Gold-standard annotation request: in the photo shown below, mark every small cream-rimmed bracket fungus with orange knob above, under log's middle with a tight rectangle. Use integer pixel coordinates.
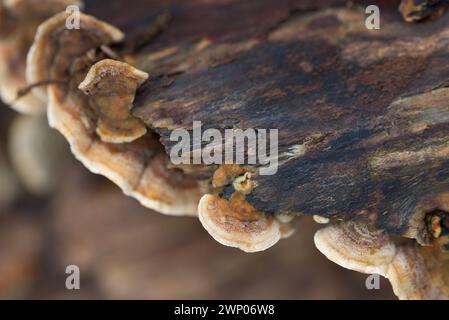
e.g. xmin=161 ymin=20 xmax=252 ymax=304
xmin=198 ymin=164 xmax=295 ymax=252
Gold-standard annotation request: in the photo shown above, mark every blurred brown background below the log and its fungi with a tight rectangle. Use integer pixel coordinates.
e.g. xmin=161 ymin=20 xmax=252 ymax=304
xmin=0 ymin=106 xmax=394 ymax=299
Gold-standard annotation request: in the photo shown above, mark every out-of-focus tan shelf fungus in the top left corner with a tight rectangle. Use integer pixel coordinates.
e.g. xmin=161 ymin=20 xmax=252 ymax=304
xmin=0 ymin=0 xmax=82 ymax=114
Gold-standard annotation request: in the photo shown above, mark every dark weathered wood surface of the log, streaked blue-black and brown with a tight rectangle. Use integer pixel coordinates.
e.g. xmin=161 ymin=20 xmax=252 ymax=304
xmin=96 ymin=1 xmax=449 ymax=239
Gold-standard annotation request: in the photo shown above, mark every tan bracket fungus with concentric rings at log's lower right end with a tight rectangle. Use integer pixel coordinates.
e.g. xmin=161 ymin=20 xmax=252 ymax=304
xmin=315 ymin=222 xmax=449 ymax=299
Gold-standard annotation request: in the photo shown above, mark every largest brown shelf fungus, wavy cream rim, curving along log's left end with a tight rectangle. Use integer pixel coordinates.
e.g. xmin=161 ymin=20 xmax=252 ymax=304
xmin=27 ymin=13 xmax=200 ymax=215
